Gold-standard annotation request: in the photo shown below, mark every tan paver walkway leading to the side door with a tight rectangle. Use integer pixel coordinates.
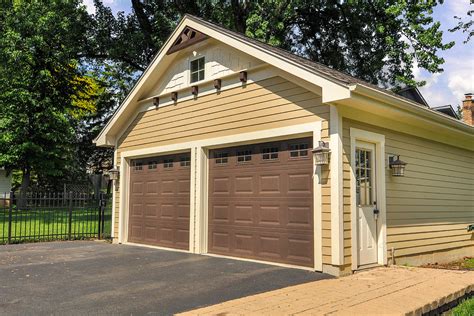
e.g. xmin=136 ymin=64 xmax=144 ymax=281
xmin=181 ymin=267 xmax=474 ymax=315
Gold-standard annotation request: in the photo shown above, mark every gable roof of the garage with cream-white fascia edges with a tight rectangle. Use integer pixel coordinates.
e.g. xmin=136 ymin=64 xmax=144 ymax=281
xmin=94 ymin=15 xmax=474 ymax=146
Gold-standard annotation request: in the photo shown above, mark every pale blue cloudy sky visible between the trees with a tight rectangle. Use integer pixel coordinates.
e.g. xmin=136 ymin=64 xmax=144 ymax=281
xmin=83 ymin=0 xmax=474 ymax=108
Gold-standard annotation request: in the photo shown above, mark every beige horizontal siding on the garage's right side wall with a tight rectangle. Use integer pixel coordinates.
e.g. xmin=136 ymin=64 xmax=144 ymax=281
xmin=343 ymin=119 xmax=474 ymax=263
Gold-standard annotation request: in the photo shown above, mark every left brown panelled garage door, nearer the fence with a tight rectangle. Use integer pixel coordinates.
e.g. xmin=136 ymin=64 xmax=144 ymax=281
xmin=128 ymin=154 xmax=191 ymax=249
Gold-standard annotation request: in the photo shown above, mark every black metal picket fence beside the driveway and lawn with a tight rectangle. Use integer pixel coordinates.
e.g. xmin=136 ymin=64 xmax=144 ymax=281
xmin=0 ymin=192 xmax=112 ymax=244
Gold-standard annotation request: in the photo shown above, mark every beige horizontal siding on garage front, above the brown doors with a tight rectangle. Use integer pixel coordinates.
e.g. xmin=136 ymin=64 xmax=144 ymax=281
xmin=114 ymin=77 xmax=330 ymax=237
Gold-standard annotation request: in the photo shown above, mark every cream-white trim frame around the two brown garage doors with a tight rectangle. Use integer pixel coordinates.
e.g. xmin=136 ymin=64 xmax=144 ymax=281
xmin=118 ymin=121 xmax=322 ymax=271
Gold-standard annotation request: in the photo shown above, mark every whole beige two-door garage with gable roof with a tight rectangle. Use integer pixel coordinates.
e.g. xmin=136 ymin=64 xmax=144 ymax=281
xmin=95 ymin=15 xmax=474 ymax=275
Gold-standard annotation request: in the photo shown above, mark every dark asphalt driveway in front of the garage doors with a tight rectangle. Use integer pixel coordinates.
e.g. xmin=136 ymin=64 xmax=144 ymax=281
xmin=0 ymin=241 xmax=330 ymax=315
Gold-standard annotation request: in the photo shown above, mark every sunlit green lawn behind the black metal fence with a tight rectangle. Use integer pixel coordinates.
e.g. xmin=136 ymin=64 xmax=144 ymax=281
xmin=0 ymin=206 xmax=112 ymax=244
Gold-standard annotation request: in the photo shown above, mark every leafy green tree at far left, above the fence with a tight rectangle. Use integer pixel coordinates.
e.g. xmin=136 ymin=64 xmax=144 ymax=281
xmin=0 ymin=0 xmax=94 ymax=190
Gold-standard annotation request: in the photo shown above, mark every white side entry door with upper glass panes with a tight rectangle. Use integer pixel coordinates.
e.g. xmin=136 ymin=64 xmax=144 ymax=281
xmin=355 ymin=141 xmax=378 ymax=266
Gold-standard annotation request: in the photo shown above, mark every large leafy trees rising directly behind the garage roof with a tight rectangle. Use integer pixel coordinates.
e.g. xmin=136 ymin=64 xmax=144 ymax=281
xmin=90 ymin=0 xmax=454 ymax=88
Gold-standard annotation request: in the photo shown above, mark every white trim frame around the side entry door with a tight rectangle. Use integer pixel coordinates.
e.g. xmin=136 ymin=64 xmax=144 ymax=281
xmin=350 ymin=127 xmax=387 ymax=270
